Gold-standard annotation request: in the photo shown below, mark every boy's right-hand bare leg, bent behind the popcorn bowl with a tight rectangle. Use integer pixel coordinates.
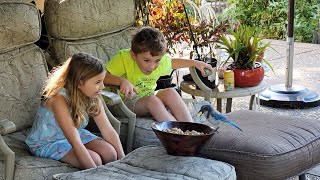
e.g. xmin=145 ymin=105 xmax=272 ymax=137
xmin=156 ymin=88 xmax=193 ymax=122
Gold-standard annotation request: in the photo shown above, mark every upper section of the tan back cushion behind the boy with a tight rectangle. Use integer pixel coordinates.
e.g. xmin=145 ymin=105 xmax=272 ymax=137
xmin=44 ymin=0 xmax=135 ymax=40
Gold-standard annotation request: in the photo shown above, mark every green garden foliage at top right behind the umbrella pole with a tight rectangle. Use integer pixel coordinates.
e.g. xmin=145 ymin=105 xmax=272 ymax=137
xmin=221 ymin=0 xmax=320 ymax=42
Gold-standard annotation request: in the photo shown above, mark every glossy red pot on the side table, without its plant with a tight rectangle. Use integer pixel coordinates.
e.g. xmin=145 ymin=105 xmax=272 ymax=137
xmin=233 ymin=63 xmax=264 ymax=87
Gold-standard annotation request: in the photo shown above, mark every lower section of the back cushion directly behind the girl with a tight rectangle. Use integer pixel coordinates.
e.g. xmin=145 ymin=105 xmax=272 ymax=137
xmin=0 ymin=44 xmax=47 ymax=130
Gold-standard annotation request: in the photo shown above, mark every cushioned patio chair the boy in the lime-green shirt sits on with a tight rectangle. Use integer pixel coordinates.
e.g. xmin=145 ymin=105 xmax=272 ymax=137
xmin=44 ymin=0 xmax=210 ymax=153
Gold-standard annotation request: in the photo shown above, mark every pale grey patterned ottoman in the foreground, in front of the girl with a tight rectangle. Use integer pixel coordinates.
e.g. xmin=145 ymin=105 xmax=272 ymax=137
xmin=53 ymin=146 xmax=236 ymax=180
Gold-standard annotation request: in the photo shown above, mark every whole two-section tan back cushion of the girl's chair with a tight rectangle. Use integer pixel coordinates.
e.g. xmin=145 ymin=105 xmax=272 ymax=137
xmin=0 ymin=3 xmax=47 ymax=130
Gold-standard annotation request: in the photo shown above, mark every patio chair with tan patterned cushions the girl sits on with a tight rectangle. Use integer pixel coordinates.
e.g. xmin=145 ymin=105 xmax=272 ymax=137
xmin=0 ymin=0 xmax=131 ymax=180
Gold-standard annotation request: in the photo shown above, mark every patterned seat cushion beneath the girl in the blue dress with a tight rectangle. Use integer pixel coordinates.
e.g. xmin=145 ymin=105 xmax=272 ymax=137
xmin=0 ymin=130 xmax=78 ymax=180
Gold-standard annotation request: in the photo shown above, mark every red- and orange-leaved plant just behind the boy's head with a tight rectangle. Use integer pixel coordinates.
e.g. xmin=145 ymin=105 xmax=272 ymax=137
xmin=149 ymin=0 xmax=229 ymax=88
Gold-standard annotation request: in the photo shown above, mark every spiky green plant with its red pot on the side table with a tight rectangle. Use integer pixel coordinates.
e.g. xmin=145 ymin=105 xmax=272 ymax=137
xmin=218 ymin=25 xmax=273 ymax=87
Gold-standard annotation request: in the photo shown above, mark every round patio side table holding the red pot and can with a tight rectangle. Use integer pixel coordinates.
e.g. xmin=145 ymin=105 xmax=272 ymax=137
xmin=180 ymin=80 xmax=268 ymax=113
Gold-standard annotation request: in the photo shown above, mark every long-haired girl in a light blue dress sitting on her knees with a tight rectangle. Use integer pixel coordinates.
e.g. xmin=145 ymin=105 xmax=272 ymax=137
xmin=26 ymin=53 xmax=124 ymax=169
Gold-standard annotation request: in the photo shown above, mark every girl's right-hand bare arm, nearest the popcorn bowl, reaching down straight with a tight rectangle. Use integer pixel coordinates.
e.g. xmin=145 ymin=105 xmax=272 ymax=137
xmin=93 ymin=102 xmax=125 ymax=159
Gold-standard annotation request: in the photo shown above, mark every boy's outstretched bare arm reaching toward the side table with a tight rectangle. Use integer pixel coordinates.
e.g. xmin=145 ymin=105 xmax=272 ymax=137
xmin=172 ymin=58 xmax=213 ymax=75
